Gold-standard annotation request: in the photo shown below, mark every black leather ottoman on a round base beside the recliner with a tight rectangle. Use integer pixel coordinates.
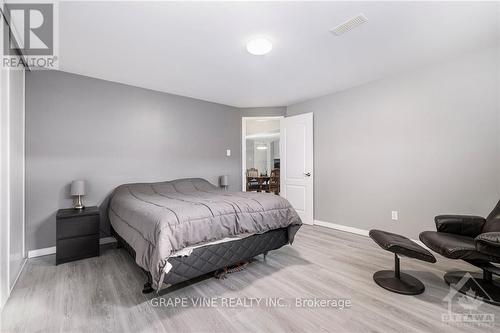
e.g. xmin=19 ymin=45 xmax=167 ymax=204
xmin=370 ymin=230 xmax=436 ymax=295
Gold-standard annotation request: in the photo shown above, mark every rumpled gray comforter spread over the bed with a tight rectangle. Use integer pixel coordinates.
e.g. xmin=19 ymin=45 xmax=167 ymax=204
xmin=109 ymin=178 xmax=302 ymax=289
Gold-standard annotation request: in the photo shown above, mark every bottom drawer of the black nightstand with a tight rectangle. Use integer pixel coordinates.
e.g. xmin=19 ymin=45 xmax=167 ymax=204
xmin=56 ymin=234 xmax=99 ymax=264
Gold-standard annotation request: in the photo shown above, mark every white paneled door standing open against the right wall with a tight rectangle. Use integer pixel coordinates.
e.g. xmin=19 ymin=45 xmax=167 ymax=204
xmin=281 ymin=113 xmax=314 ymax=224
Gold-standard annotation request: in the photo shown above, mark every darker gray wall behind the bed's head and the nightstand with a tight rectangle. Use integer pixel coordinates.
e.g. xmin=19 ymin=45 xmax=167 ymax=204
xmin=26 ymin=71 xmax=241 ymax=250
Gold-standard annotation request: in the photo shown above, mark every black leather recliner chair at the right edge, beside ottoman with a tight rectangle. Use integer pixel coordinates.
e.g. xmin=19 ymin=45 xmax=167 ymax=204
xmin=420 ymin=201 xmax=500 ymax=305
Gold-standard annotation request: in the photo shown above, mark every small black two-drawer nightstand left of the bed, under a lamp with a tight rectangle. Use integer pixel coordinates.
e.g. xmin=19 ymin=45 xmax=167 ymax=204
xmin=56 ymin=207 xmax=99 ymax=265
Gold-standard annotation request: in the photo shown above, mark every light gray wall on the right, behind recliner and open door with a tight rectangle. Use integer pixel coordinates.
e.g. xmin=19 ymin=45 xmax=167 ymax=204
xmin=287 ymin=49 xmax=500 ymax=238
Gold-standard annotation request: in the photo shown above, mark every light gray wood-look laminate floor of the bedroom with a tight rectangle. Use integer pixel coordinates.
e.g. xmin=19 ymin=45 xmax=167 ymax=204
xmin=0 ymin=226 xmax=500 ymax=333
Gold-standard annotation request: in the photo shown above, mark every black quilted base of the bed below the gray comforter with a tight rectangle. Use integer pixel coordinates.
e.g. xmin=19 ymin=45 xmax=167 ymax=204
xmin=111 ymin=228 xmax=290 ymax=294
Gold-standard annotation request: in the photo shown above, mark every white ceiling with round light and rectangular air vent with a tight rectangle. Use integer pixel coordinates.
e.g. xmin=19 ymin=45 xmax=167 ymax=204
xmin=59 ymin=2 xmax=500 ymax=107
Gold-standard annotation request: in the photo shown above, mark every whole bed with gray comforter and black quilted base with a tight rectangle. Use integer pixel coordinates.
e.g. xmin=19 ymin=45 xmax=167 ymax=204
xmin=108 ymin=178 xmax=302 ymax=292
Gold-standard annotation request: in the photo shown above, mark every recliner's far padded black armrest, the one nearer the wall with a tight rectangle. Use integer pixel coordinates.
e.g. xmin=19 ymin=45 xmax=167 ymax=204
xmin=434 ymin=215 xmax=486 ymax=237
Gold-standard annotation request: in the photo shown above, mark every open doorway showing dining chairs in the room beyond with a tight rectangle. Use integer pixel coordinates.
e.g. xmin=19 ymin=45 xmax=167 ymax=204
xmin=241 ymin=117 xmax=283 ymax=195
